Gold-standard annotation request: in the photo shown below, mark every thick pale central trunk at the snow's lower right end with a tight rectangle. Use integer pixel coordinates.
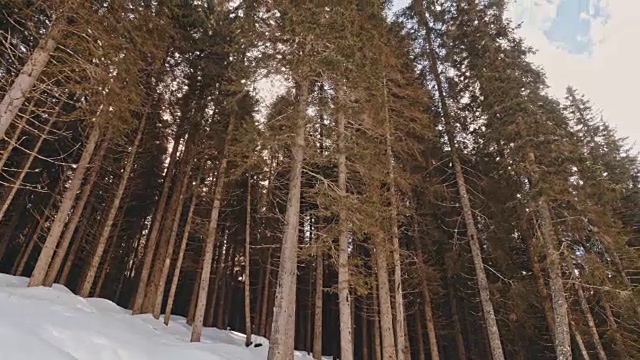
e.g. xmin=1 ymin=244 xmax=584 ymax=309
xmin=267 ymin=80 xmax=309 ymax=360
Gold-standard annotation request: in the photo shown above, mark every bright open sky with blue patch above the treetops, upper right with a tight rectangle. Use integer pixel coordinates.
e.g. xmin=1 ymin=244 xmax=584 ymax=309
xmin=394 ymin=0 xmax=640 ymax=151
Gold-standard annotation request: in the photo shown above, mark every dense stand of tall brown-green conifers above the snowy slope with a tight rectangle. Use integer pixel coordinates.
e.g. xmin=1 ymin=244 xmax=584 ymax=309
xmin=0 ymin=0 xmax=640 ymax=360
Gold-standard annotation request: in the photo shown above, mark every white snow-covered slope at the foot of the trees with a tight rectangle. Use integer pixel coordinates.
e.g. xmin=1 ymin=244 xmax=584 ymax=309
xmin=0 ymin=274 xmax=310 ymax=360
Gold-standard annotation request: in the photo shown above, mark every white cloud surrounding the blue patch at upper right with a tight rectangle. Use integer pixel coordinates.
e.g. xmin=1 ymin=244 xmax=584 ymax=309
xmin=509 ymin=0 xmax=640 ymax=148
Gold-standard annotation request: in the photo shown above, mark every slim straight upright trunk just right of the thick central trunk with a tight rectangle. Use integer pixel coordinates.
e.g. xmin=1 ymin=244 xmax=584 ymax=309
xmin=337 ymin=105 xmax=356 ymax=360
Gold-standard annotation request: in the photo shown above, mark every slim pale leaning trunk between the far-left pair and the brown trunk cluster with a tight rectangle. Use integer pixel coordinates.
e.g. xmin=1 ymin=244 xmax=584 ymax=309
xmin=80 ymin=112 xmax=147 ymax=297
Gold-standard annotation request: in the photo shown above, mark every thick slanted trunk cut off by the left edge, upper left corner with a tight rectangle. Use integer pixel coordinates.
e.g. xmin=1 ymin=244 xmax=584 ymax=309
xmin=0 ymin=20 xmax=60 ymax=138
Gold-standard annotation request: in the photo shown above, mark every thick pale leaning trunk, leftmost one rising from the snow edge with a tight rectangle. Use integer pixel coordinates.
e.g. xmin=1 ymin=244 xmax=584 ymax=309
xmin=29 ymin=123 xmax=100 ymax=286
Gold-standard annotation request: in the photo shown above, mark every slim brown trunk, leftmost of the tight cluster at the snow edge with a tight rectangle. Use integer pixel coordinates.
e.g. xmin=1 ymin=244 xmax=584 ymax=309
xmin=132 ymin=131 xmax=182 ymax=315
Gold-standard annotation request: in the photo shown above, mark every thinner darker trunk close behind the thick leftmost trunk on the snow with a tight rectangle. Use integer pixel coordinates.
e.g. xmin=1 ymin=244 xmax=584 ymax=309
xmin=44 ymin=134 xmax=109 ymax=286
